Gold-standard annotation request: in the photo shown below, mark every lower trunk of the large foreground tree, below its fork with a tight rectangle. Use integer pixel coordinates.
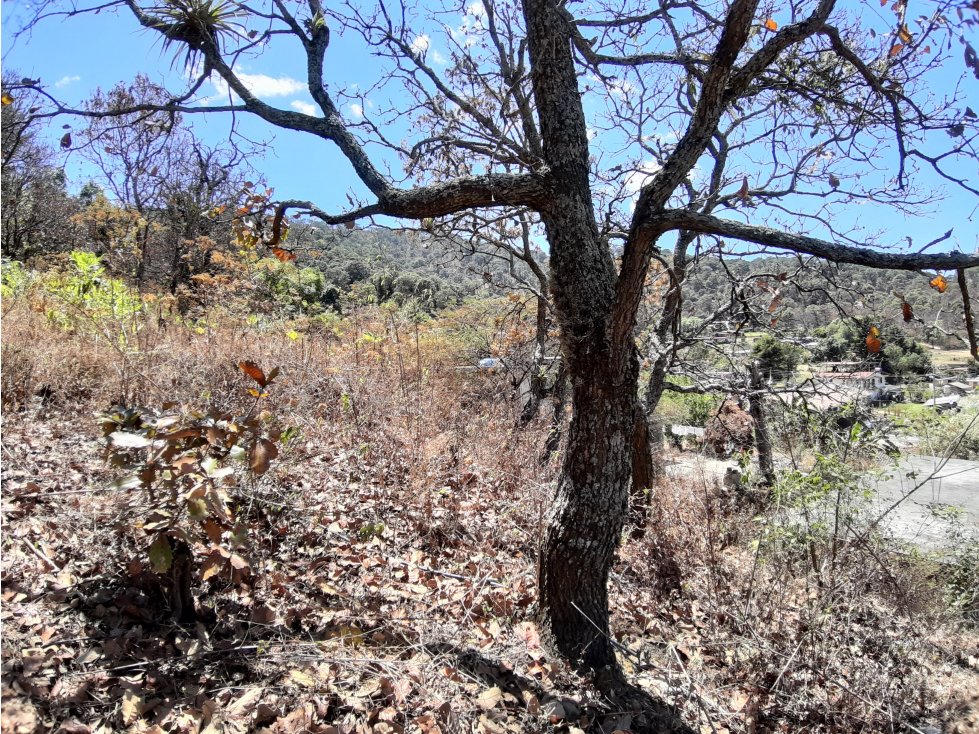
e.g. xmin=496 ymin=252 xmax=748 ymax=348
xmin=537 ymin=356 xmax=637 ymax=670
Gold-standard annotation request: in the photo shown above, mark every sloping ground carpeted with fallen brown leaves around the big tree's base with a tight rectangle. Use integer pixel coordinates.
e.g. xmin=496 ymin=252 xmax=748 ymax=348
xmin=2 ymin=402 xmax=979 ymax=734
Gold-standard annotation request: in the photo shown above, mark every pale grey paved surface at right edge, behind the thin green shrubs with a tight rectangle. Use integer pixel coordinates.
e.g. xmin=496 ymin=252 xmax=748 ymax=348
xmin=867 ymin=456 xmax=979 ymax=548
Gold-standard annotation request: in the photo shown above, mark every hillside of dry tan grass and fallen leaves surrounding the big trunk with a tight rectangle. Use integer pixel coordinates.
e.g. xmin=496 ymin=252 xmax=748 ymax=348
xmin=3 ymin=304 xmax=979 ymax=734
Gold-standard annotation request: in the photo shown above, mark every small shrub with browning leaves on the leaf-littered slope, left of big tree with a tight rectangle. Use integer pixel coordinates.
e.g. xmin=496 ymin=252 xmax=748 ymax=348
xmin=99 ymin=361 xmax=296 ymax=621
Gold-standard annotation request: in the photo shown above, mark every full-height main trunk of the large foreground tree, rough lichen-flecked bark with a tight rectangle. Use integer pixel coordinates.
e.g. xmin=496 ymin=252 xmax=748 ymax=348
xmin=524 ymin=0 xmax=639 ymax=669
